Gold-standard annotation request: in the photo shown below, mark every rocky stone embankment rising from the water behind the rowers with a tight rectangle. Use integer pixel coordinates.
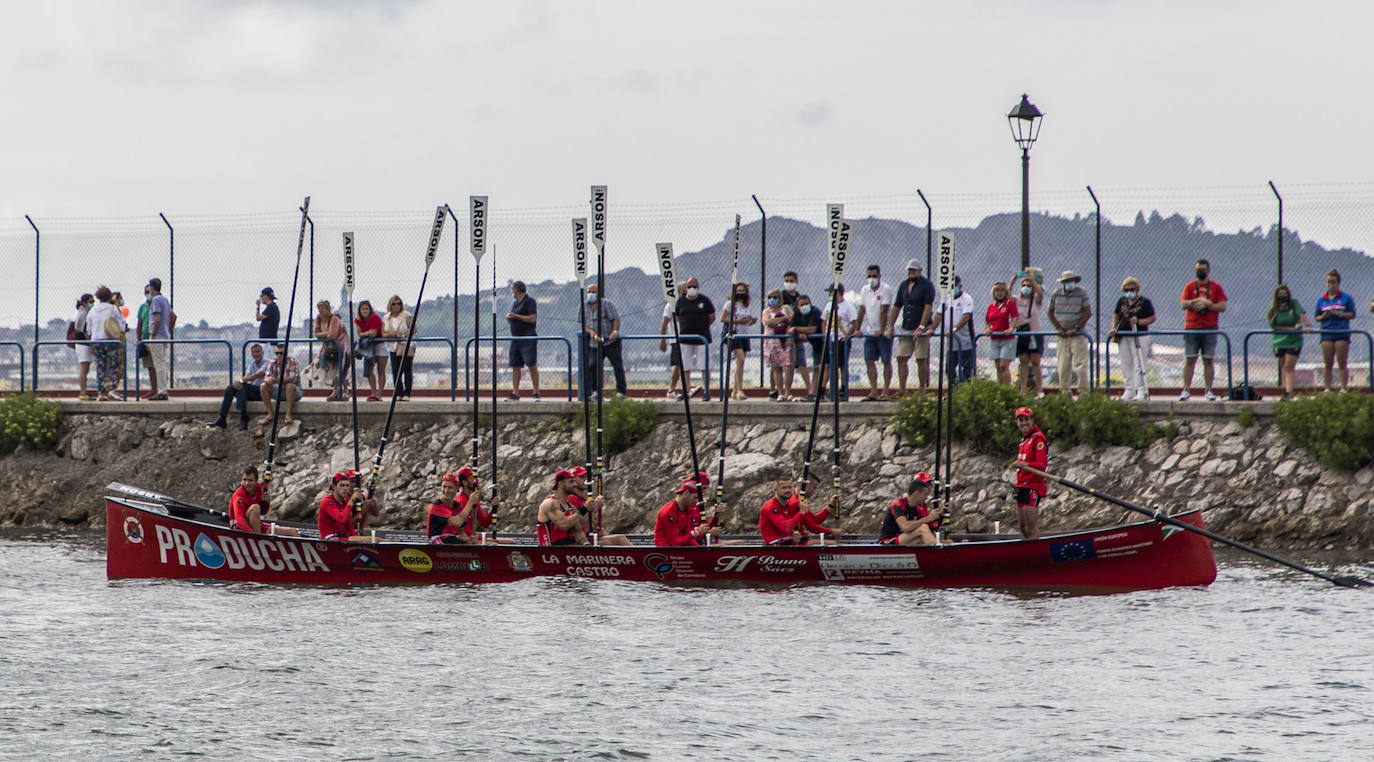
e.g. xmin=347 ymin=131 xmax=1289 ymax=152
xmin=0 ymin=404 xmax=1374 ymax=549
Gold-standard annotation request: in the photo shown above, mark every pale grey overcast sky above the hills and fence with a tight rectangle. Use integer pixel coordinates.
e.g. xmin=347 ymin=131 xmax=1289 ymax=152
xmin=0 ymin=0 xmax=1374 ymax=324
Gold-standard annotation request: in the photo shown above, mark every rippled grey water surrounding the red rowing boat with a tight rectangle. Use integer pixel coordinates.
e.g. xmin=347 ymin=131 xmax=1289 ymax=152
xmin=0 ymin=533 xmax=1374 ymax=761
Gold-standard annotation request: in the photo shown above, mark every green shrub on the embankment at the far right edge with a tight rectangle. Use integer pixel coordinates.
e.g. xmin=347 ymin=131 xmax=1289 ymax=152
xmin=1274 ymin=391 xmax=1374 ymax=471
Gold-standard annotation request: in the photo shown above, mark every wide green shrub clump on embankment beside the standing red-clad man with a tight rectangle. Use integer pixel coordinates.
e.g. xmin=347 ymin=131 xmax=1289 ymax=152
xmin=892 ymin=379 xmax=1169 ymax=454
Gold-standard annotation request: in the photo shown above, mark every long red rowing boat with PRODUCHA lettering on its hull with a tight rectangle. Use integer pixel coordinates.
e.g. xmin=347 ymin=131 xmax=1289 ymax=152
xmin=106 ymin=485 xmax=1216 ymax=592
